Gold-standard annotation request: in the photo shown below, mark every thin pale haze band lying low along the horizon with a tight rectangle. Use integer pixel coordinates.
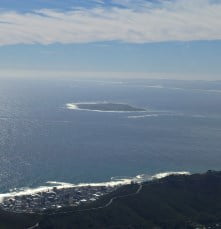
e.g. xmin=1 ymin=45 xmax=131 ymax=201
xmin=0 ymin=69 xmax=220 ymax=81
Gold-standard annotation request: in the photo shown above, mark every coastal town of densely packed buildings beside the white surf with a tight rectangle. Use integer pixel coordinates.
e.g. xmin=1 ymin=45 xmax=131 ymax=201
xmin=0 ymin=185 xmax=117 ymax=213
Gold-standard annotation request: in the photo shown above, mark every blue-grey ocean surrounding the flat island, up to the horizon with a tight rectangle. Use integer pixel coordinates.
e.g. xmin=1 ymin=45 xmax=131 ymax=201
xmin=0 ymin=78 xmax=221 ymax=193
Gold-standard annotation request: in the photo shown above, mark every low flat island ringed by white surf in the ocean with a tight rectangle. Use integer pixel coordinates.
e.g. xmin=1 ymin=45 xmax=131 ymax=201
xmin=67 ymin=102 xmax=146 ymax=112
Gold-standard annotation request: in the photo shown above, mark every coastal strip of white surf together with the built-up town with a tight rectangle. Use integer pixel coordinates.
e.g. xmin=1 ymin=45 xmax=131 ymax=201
xmin=0 ymin=171 xmax=190 ymax=213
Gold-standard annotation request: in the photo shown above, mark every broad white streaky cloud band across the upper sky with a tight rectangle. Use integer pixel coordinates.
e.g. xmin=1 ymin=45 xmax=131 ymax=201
xmin=0 ymin=0 xmax=221 ymax=45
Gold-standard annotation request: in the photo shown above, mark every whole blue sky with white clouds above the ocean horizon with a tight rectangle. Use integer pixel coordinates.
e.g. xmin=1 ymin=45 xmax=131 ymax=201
xmin=0 ymin=0 xmax=221 ymax=80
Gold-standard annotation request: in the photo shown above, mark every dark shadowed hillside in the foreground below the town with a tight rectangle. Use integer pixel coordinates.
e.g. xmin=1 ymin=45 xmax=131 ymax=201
xmin=0 ymin=171 xmax=221 ymax=229
